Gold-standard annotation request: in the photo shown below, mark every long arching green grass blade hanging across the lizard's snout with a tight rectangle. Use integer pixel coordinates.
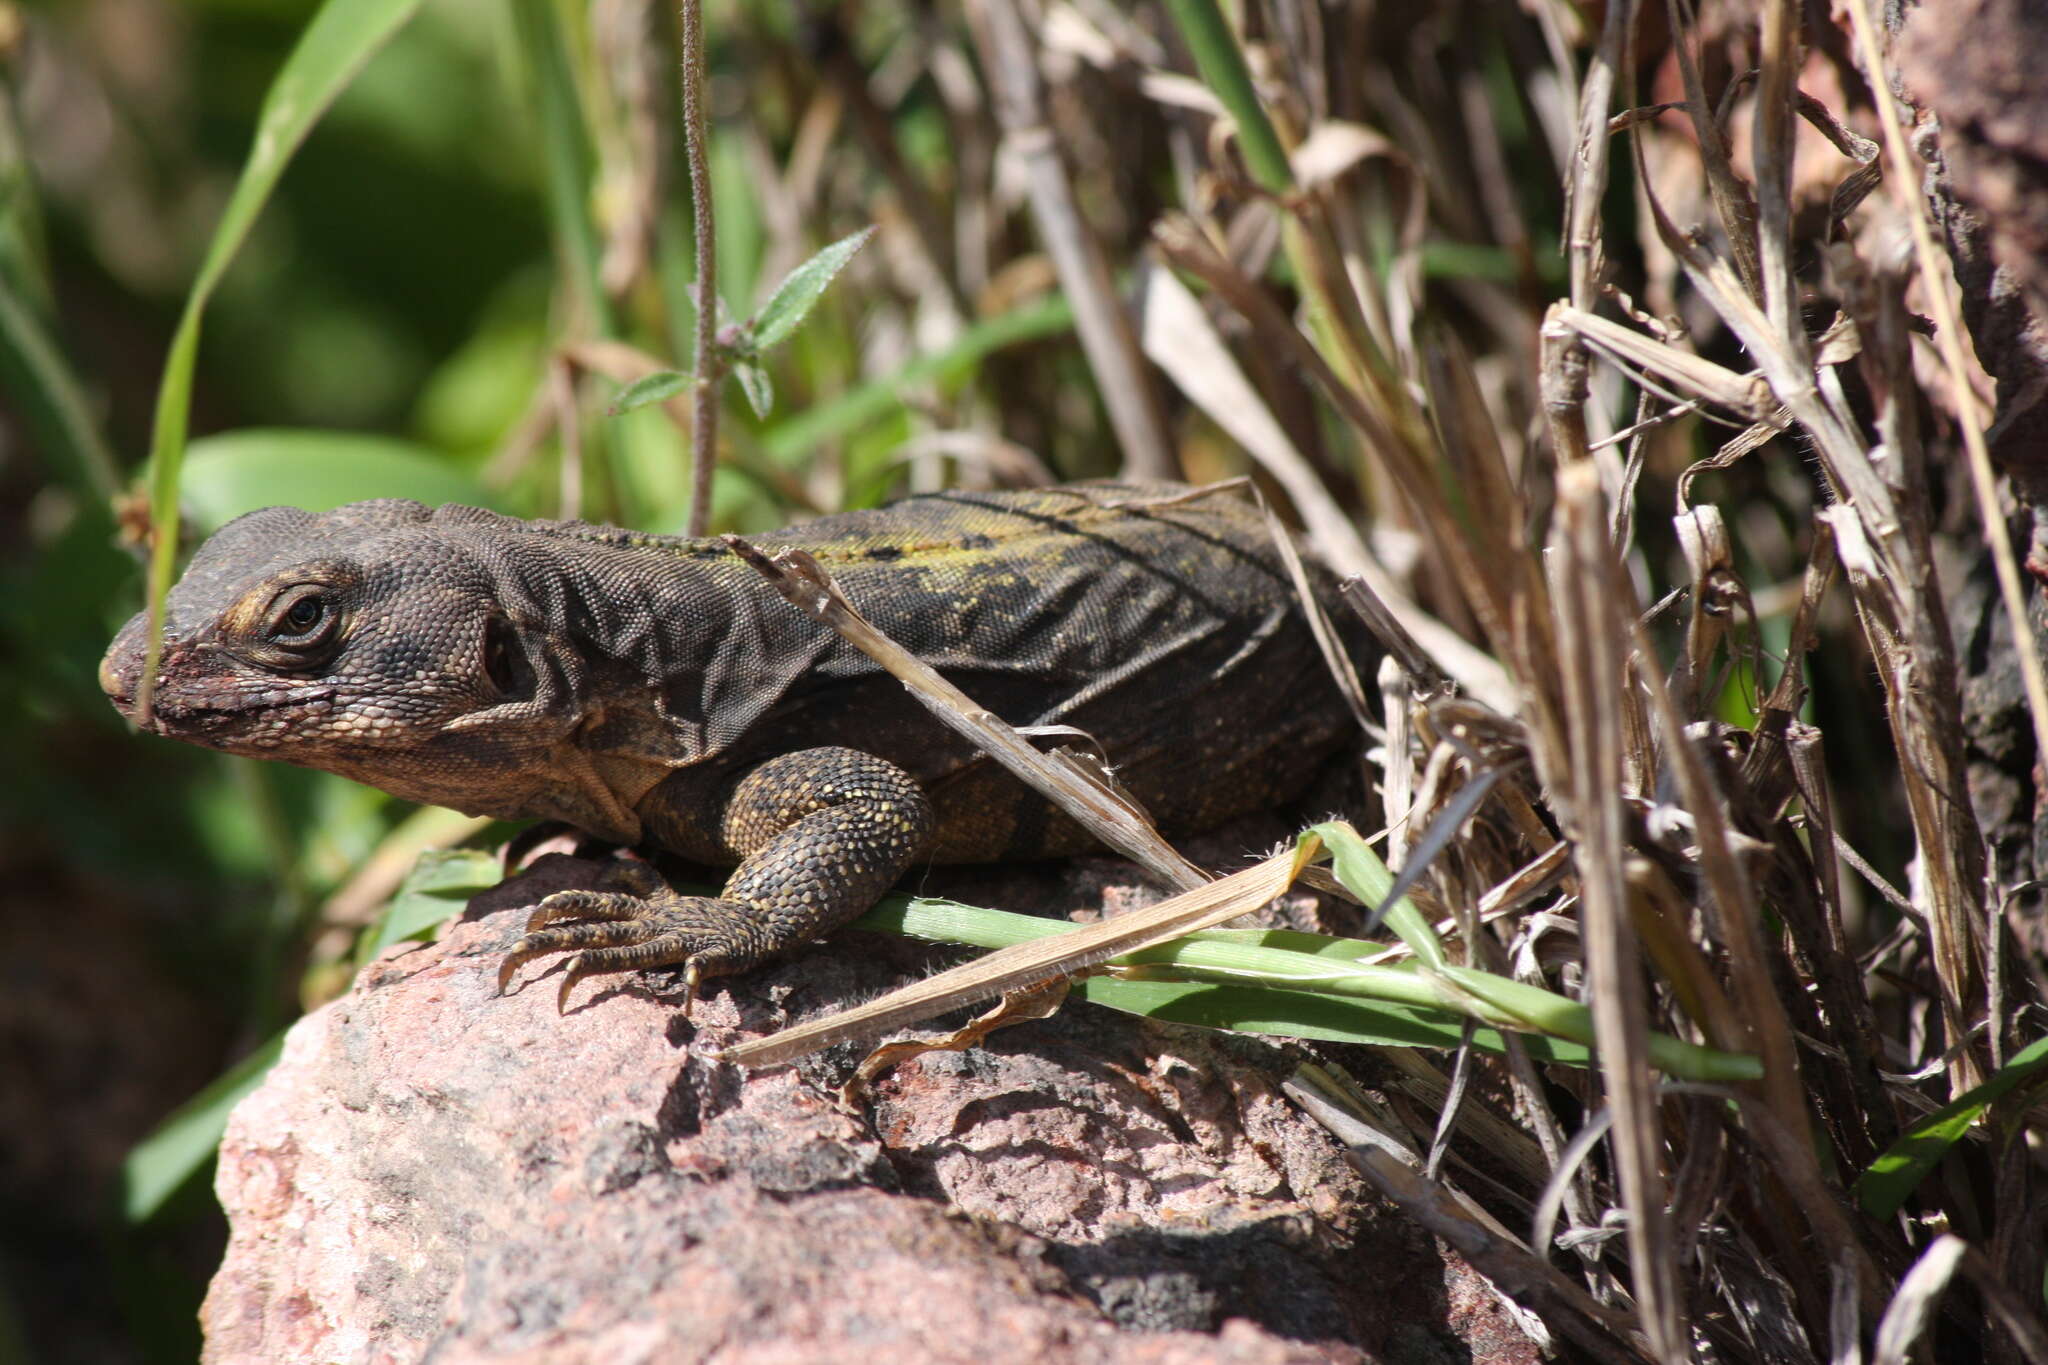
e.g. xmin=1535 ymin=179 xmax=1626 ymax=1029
xmin=145 ymin=0 xmax=432 ymax=703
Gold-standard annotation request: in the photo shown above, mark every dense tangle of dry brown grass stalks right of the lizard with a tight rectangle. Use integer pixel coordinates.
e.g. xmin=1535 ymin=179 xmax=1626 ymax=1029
xmin=638 ymin=0 xmax=2048 ymax=1361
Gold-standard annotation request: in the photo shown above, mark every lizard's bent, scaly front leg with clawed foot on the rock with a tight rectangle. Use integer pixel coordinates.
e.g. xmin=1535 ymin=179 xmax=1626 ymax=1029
xmin=498 ymin=749 xmax=936 ymax=1009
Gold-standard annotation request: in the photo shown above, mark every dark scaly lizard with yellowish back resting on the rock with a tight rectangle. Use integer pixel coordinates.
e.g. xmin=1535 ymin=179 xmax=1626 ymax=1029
xmin=100 ymin=481 xmax=1370 ymax=1001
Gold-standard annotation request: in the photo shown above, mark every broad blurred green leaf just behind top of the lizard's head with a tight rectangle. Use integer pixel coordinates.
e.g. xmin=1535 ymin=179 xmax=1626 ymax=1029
xmin=182 ymin=428 xmax=494 ymax=532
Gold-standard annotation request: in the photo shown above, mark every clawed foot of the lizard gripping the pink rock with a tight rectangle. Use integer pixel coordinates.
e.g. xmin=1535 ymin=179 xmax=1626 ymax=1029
xmin=498 ymin=888 xmax=760 ymax=1013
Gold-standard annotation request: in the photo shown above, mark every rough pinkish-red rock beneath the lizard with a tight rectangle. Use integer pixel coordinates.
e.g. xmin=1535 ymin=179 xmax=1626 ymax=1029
xmin=203 ymin=860 xmax=1538 ymax=1365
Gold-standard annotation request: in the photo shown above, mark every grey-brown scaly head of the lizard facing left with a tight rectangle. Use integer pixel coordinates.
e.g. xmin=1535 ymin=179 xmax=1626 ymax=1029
xmin=100 ymin=499 xmax=547 ymax=802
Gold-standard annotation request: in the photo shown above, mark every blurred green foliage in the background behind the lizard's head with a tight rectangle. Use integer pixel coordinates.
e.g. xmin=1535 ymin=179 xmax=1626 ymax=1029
xmin=0 ymin=0 xmax=1138 ymax=1359
